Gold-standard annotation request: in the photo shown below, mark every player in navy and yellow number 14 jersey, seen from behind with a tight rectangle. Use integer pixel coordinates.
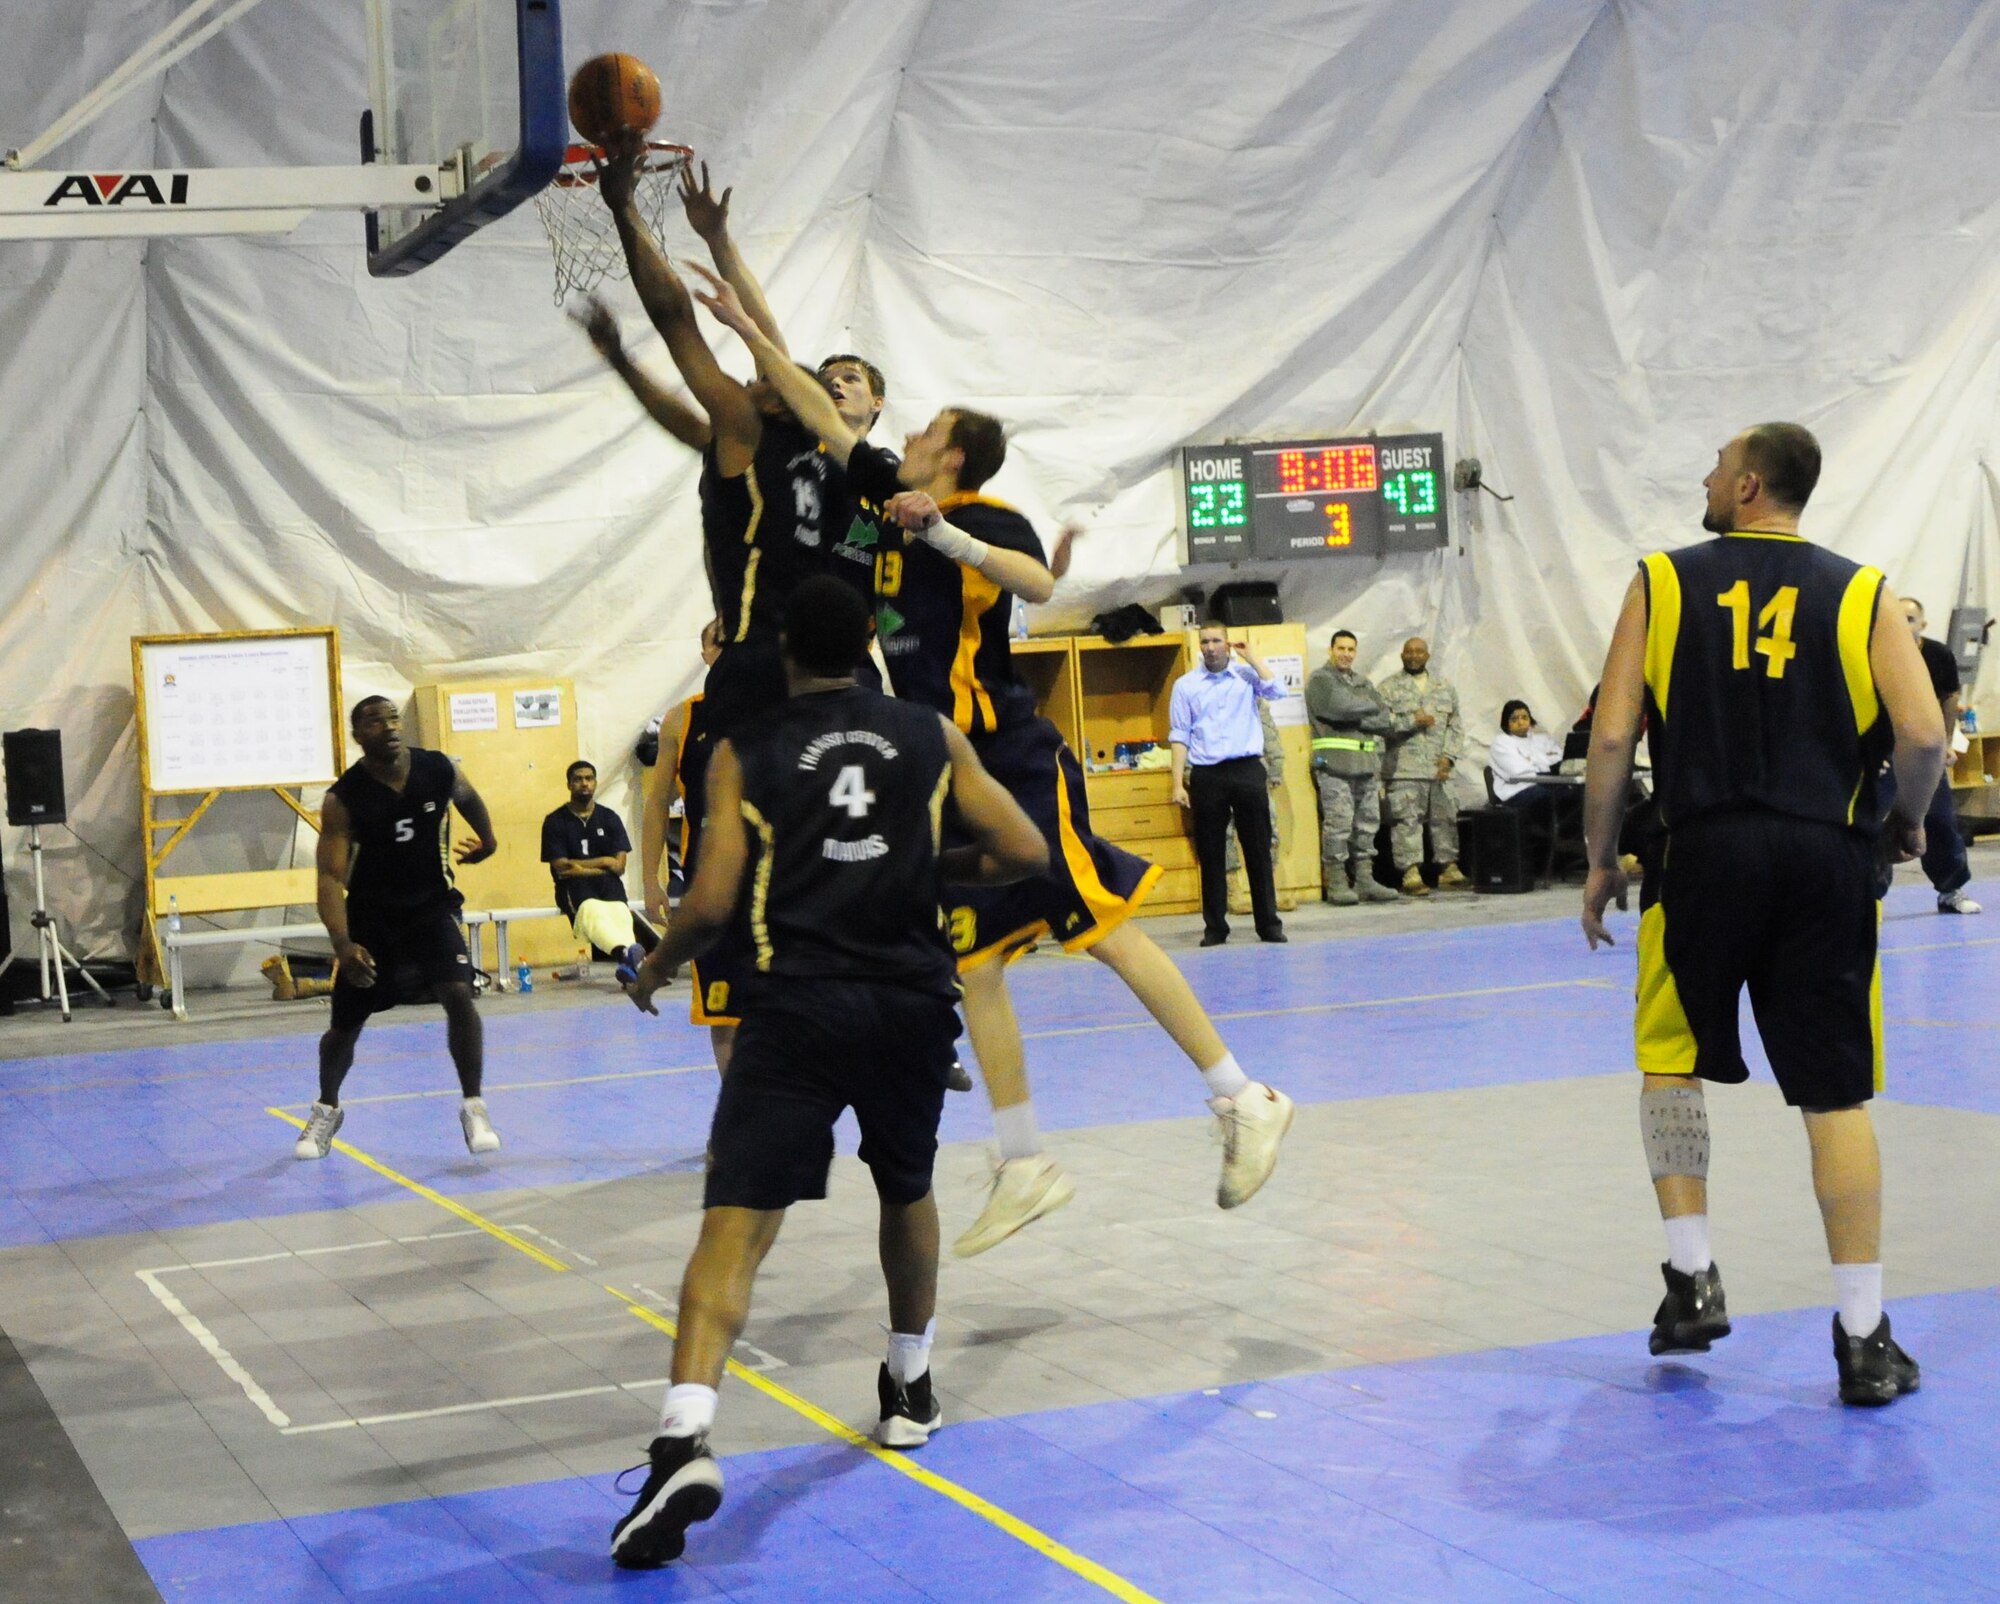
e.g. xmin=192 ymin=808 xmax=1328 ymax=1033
xmin=1584 ymin=424 xmax=1944 ymax=1404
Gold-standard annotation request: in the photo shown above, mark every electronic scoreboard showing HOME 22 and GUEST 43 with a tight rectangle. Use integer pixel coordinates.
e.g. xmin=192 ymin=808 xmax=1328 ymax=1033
xmin=1180 ymin=434 xmax=1450 ymax=562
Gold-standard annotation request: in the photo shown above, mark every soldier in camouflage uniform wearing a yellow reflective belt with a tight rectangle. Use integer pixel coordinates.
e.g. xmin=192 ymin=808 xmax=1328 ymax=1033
xmin=1306 ymin=630 xmax=1396 ymax=908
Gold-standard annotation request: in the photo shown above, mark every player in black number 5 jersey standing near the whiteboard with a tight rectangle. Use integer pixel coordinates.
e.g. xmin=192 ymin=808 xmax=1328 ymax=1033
xmin=294 ymin=696 xmax=500 ymax=1158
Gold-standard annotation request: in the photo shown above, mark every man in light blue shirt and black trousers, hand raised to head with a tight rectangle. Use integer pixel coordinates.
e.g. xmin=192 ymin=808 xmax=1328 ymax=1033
xmin=1168 ymin=624 xmax=1284 ymax=946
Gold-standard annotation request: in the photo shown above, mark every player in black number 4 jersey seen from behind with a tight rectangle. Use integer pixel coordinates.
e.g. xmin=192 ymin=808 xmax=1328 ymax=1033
xmin=612 ymin=576 xmax=1048 ymax=1568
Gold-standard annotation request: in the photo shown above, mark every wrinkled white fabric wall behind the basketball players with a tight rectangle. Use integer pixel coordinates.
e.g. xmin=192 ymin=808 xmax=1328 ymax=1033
xmin=0 ymin=0 xmax=2000 ymax=964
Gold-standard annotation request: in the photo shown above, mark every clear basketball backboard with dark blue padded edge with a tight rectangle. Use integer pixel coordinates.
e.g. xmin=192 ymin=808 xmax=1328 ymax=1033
xmin=362 ymin=0 xmax=570 ymax=278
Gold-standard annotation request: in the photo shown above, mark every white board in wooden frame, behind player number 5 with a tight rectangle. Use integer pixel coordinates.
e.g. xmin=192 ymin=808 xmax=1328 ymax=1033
xmin=132 ymin=630 xmax=340 ymax=792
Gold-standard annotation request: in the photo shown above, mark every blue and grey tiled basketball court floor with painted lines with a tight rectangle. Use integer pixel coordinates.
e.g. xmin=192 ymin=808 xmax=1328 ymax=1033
xmin=0 ymin=886 xmax=2000 ymax=1604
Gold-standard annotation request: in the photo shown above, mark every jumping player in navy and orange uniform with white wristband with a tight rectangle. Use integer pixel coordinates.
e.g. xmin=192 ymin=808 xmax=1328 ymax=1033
xmin=702 ymin=276 xmax=1294 ymax=1256
